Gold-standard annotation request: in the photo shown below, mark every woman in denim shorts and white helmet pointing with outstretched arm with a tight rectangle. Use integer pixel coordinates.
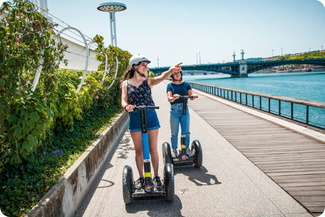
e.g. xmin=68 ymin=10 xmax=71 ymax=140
xmin=121 ymin=54 xmax=182 ymax=203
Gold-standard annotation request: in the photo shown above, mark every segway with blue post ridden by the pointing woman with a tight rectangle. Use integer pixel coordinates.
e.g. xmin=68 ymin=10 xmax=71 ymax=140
xmin=123 ymin=106 xmax=175 ymax=204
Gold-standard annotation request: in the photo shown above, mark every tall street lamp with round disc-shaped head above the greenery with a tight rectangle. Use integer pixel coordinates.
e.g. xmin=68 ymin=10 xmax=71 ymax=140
xmin=97 ymin=2 xmax=126 ymax=47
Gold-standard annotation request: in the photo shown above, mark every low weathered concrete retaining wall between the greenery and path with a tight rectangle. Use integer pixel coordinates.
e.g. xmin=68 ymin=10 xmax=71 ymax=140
xmin=26 ymin=112 xmax=128 ymax=217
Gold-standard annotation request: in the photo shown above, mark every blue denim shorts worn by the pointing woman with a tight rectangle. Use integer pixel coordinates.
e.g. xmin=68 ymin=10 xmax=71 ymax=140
xmin=129 ymin=109 xmax=160 ymax=132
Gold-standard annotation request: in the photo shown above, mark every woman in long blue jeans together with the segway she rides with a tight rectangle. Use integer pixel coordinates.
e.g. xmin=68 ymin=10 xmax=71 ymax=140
xmin=163 ymin=71 xmax=202 ymax=168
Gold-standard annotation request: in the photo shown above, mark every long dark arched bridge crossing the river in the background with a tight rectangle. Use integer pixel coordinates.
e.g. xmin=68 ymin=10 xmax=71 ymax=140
xmin=150 ymin=58 xmax=325 ymax=76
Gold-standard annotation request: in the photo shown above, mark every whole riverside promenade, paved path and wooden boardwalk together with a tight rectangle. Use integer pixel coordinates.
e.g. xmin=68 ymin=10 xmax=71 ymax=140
xmin=75 ymin=83 xmax=325 ymax=217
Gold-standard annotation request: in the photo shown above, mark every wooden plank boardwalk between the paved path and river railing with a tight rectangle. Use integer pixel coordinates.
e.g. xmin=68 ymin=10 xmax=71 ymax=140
xmin=189 ymin=89 xmax=325 ymax=216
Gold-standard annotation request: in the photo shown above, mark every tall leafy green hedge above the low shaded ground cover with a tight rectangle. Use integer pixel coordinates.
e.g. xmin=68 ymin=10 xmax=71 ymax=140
xmin=0 ymin=0 xmax=130 ymax=168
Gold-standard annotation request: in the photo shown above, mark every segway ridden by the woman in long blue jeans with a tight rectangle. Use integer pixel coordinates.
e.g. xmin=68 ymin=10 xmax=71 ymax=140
xmin=162 ymin=95 xmax=203 ymax=168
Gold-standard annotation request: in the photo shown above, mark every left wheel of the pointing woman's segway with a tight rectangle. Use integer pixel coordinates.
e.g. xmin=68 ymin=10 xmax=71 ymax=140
xmin=122 ymin=165 xmax=133 ymax=204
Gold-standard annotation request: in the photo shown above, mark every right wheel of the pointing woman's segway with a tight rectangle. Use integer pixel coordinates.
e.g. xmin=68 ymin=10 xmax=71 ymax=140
xmin=164 ymin=163 xmax=175 ymax=202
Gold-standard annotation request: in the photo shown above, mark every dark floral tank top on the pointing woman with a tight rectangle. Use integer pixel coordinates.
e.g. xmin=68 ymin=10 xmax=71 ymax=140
xmin=128 ymin=79 xmax=155 ymax=106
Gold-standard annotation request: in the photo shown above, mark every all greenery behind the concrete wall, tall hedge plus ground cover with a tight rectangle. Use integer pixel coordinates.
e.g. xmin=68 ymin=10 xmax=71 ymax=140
xmin=0 ymin=0 xmax=130 ymax=216
